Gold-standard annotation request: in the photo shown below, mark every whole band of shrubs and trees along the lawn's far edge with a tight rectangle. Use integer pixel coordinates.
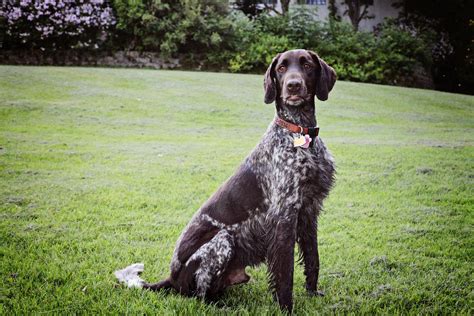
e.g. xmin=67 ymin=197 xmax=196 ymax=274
xmin=0 ymin=0 xmax=474 ymax=94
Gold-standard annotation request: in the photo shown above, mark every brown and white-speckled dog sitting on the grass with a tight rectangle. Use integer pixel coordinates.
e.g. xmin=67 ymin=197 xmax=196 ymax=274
xmin=115 ymin=49 xmax=336 ymax=312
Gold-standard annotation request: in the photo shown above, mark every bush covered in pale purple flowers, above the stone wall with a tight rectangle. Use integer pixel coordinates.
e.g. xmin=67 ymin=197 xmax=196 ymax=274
xmin=0 ymin=0 xmax=115 ymax=50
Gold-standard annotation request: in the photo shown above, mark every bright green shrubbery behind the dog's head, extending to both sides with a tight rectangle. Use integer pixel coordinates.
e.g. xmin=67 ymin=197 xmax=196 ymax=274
xmin=229 ymin=9 xmax=431 ymax=84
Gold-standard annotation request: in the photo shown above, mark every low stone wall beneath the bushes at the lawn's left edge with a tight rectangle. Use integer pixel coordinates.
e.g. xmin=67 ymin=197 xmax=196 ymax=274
xmin=0 ymin=50 xmax=181 ymax=69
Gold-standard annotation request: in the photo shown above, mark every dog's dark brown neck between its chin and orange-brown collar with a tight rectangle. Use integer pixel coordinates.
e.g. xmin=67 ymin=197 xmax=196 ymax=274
xmin=276 ymin=98 xmax=317 ymax=127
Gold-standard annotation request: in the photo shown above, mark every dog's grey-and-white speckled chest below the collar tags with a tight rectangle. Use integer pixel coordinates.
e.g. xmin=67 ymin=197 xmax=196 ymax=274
xmin=249 ymin=129 xmax=334 ymax=212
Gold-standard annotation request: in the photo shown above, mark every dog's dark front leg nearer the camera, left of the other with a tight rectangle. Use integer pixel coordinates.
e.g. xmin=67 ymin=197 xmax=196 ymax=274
xmin=267 ymin=216 xmax=297 ymax=313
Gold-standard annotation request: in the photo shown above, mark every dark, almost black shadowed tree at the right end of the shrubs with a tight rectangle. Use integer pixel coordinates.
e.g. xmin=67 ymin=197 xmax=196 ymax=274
xmin=394 ymin=0 xmax=474 ymax=94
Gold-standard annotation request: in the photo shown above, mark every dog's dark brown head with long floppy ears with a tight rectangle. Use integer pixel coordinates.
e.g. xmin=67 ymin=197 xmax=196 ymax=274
xmin=264 ymin=49 xmax=336 ymax=106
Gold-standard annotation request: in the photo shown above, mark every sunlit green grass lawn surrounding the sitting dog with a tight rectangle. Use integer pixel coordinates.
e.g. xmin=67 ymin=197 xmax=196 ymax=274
xmin=0 ymin=66 xmax=474 ymax=315
